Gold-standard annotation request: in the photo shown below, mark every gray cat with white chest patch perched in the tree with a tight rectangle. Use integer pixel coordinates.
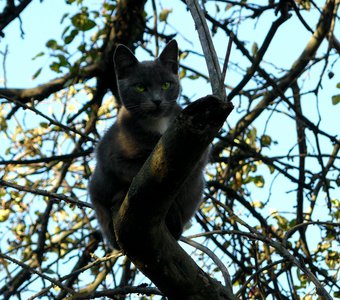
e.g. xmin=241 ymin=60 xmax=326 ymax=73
xmin=89 ymin=40 xmax=208 ymax=249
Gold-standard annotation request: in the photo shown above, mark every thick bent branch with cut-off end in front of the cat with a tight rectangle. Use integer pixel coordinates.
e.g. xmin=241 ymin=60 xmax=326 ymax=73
xmin=116 ymin=96 xmax=235 ymax=299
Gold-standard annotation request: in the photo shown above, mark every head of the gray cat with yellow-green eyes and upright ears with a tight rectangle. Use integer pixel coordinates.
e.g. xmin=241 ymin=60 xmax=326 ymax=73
xmin=114 ymin=40 xmax=180 ymax=117
